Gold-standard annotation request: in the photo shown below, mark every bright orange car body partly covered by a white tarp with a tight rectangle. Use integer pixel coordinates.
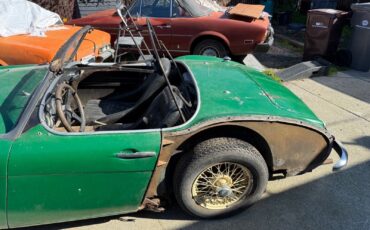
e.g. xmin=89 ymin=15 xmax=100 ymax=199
xmin=0 ymin=26 xmax=110 ymax=65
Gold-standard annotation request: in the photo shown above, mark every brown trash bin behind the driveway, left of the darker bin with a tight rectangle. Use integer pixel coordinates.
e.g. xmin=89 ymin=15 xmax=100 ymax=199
xmin=303 ymin=9 xmax=348 ymax=60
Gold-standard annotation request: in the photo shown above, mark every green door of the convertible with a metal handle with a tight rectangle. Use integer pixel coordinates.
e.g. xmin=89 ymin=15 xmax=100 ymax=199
xmin=8 ymin=125 xmax=161 ymax=227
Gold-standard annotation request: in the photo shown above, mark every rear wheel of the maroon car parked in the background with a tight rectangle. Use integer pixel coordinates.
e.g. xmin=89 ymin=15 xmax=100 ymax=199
xmin=193 ymin=39 xmax=228 ymax=58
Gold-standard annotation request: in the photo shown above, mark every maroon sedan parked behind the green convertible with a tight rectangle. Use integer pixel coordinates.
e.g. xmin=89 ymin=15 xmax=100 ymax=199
xmin=69 ymin=0 xmax=273 ymax=57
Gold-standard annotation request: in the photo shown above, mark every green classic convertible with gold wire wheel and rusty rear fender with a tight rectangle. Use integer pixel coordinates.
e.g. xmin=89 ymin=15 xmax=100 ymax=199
xmin=0 ymin=22 xmax=347 ymax=228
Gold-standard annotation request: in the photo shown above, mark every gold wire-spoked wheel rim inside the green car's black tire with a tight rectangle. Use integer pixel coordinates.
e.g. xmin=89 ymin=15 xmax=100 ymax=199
xmin=192 ymin=162 xmax=253 ymax=209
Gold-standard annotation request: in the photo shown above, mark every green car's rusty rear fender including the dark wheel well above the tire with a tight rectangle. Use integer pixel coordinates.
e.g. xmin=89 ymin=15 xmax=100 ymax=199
xmin=146 ymin=116 xmax=334 ymax=203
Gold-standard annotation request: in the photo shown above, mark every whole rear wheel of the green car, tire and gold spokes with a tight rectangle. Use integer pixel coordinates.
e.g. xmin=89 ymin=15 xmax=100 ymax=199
xmin=174 ymin=138 xmax=268 ymax=218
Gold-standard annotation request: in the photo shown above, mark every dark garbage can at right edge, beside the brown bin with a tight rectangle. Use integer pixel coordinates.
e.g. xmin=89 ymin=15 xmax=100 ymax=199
xmin=350 ymin=3 xmax=370 ymax=71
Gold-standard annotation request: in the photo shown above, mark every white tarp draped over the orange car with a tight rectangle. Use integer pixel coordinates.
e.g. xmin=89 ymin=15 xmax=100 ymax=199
xmin=0 ymin=0 xmax=63 ymax=37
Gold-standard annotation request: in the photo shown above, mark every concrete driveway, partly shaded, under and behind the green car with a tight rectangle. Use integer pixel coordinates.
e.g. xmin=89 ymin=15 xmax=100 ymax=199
xmin=26 ymin=71 xmax=370 ymax=230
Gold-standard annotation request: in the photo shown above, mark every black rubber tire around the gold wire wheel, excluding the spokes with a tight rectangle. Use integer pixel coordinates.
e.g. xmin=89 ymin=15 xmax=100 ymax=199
xmin=173 ymin=137 xmax=269 ymax=218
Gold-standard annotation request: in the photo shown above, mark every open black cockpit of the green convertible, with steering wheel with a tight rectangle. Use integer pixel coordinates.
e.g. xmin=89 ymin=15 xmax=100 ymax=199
xmin=43 ymin=58 xmax=198 ymax=132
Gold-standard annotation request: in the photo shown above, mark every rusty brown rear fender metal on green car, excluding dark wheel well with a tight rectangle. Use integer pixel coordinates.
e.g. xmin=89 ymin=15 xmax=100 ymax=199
xmin=146 ymin=116 xmax=333 ymax=197
